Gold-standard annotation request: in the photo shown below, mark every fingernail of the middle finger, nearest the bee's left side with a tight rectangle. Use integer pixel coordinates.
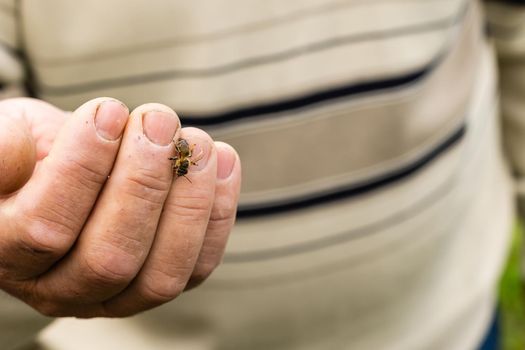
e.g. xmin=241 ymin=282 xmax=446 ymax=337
xmin=142 ymin=111 xmax=179 ymax=146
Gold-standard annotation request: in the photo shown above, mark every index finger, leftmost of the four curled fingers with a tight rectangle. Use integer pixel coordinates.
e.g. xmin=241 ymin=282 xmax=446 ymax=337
xmin=0 ymin=99 xmax=128 ymax=279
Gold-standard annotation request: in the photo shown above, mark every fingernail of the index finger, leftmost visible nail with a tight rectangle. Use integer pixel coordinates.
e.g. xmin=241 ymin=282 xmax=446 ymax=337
xmin=95 ymin=100 xmax=129 ymax=141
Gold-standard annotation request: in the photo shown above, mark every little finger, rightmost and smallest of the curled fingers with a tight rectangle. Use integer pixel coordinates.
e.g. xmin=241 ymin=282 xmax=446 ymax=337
xmin=186 ymin=142 xmax=241 ymax=290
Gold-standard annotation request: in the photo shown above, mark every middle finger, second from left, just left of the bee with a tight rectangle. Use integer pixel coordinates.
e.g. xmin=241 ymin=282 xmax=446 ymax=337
xmin=33 ymin=104 xmax=179 ymax=305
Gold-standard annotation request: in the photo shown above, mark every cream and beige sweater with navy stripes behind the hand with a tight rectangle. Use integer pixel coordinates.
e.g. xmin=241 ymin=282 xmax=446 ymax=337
xmin=0 ymin=0 xmax=525 ymax=350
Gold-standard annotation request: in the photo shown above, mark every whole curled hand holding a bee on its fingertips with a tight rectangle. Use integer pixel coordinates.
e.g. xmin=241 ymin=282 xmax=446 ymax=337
xmin=0 ymin=98 xmax=240 ymax=317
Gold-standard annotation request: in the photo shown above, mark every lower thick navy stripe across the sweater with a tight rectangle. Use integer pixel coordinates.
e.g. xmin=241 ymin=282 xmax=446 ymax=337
xmin=237 ymin=125 xmax=466 ymax=219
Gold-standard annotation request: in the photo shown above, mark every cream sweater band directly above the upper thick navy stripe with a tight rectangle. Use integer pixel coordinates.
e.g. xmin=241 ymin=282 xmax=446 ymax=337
xmin=41 ymin=26 xmax=450 ymax=114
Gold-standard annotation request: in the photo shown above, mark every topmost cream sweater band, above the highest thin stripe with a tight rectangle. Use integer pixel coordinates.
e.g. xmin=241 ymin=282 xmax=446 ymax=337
xmin=24 ymin=0 xmax=464 ymax=62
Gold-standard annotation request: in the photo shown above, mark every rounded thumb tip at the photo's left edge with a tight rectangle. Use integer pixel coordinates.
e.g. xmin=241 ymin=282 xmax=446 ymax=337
xmin=0 ymin=115 xmax=36 ymax=196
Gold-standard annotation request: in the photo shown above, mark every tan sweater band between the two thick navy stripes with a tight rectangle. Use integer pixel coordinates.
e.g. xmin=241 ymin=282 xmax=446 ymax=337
xmin=206 ymin=2 xmax=481 ymax=205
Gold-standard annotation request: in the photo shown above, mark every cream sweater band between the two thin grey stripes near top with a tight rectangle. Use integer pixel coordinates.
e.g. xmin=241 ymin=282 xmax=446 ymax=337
xmin=31 ymin=0 xmax=463 ymax=87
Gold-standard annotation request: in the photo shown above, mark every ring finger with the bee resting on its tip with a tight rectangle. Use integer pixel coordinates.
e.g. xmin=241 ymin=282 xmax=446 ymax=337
xmin=105 ymin=128 xmax=217 ymax=316
